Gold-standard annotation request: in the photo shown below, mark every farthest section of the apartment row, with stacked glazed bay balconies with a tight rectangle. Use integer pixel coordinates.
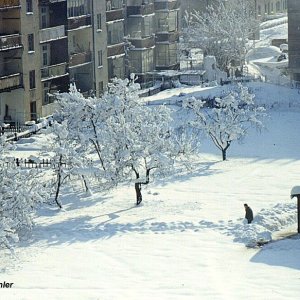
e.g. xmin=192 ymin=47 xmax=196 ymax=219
xmin=126 ymin=0 xmax=180 ymax=84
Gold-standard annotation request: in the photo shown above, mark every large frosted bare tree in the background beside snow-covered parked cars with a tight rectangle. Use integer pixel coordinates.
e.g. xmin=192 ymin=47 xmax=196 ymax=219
xmin=183 ymin=0 xmax=259 ymax=70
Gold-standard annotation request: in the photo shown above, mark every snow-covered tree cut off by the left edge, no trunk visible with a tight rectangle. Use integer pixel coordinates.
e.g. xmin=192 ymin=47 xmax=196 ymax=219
xmin=0 ymin=139 xmax=48 ymax=249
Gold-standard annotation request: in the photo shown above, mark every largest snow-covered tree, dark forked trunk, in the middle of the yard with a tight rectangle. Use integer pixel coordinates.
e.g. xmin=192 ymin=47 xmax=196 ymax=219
xmin=56 ymin=79 xmax=182 ymax=204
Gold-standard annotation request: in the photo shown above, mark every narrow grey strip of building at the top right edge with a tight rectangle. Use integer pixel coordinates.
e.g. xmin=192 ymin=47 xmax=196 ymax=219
xmin=288 ymin=0 xmax=300 ymax=85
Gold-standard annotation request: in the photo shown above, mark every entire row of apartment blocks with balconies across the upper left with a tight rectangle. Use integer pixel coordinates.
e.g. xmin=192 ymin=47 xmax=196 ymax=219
xmin=0 ymin=0 xmax=179 ymax=124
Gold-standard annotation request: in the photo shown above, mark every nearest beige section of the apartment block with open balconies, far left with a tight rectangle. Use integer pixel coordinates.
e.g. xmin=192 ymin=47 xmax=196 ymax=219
xmin=0 ymin=0 xmax=108 ymax=124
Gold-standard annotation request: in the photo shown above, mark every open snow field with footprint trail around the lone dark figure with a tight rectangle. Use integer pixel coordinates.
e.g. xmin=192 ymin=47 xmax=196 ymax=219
xmin=0 ymin=80 xmax=300 ymax=300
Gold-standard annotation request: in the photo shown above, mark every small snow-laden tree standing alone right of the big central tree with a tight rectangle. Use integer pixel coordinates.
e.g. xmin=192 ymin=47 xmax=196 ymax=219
xmin=183 ymin=84 xmax=266 ymax=160
